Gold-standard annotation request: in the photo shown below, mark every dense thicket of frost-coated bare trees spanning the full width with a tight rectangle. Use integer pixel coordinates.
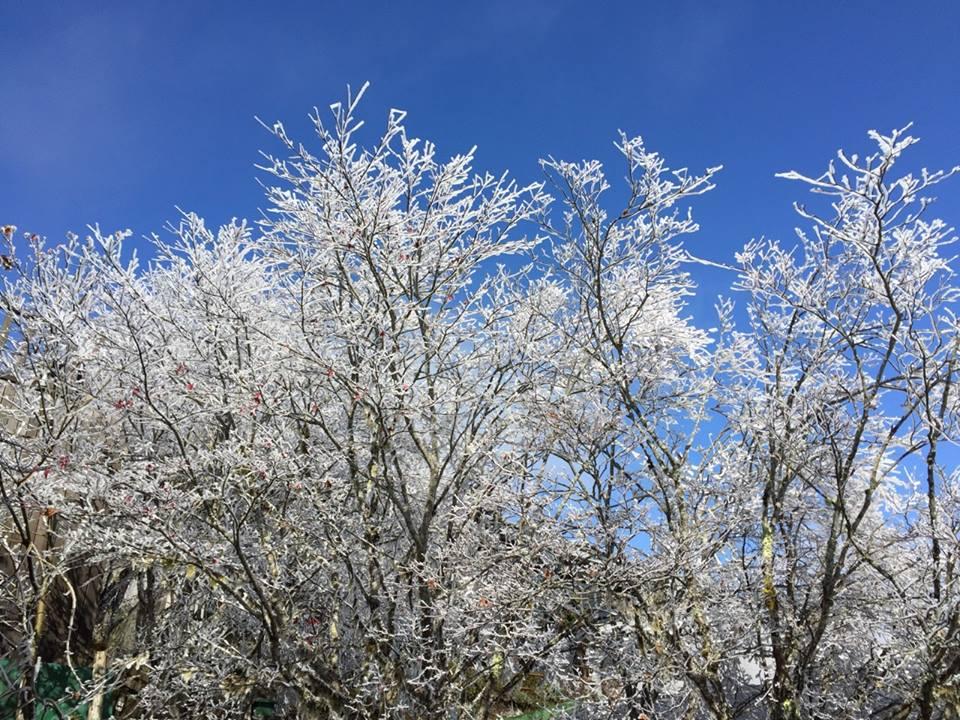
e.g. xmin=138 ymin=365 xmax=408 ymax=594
xmin=0 ymin=93 xmax=960 ymax=720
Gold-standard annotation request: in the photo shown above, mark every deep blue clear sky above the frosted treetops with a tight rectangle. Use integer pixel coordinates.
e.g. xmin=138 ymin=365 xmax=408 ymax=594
xmin=0 ymin=0 xmax=960 ymax=312
